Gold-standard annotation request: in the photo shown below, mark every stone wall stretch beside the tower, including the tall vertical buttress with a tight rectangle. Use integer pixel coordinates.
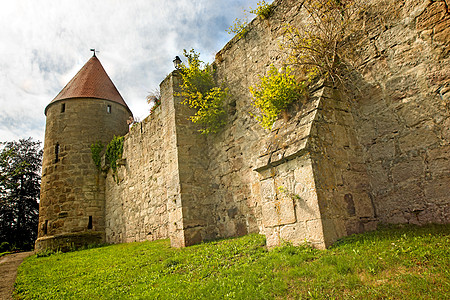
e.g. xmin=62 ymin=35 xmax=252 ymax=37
xmin=106 ymin=72 xmax=215 ymax=247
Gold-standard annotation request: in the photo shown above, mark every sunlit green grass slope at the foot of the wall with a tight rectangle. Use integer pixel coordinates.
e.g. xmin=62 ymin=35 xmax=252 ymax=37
xmin=15 ymin=225 xmax=450 ymax=299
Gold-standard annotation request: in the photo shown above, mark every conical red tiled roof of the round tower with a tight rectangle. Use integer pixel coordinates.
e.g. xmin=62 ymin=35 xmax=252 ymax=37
xmin=45 ymin=55 xmax=130 ymax=112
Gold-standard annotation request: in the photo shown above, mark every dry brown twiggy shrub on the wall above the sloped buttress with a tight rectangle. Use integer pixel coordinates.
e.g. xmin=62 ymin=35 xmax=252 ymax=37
xmin=280 ymin=0 xmax=365 ymax=84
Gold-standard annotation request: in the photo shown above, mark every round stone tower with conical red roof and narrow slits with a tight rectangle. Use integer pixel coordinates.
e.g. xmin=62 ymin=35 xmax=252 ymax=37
xmin=36 ymin=53 xmax=132 ymax=250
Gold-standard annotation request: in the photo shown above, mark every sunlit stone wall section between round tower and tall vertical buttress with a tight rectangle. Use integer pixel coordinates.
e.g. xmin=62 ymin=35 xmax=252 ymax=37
xmin=105 ymin=92 xmax=170 ymax=243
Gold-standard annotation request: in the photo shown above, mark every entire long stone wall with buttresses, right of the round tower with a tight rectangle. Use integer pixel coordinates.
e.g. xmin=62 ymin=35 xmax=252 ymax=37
xmin=106 ymin=0 xmax=450 ymax=248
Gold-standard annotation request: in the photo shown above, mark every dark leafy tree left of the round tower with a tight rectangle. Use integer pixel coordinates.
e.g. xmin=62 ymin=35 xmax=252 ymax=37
xmin=0 ymin=138 xmax=42 ymax=250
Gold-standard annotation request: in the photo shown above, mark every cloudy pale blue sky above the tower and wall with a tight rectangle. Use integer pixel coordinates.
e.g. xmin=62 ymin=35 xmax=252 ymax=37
xmin=0 ymin=0 xmax=258 ymax=142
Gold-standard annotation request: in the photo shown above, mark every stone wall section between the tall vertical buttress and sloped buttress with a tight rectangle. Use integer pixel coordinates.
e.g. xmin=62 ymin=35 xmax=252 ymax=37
xmin=208 ymin=1 xmax=308 ymax=244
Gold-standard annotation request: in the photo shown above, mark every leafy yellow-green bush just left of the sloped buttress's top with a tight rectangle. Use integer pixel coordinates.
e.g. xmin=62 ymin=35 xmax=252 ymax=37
xmin=249 ymin=65 xmax=305 ymax=129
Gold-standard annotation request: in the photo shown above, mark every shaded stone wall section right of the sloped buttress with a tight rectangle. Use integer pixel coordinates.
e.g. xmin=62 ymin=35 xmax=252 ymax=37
xmin=353 ymin=0 xmax=450 ymax=224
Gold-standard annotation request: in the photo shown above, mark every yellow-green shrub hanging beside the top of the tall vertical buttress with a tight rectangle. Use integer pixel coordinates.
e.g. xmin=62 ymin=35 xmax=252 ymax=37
xmin=180 ymin=49 xmax=227 ymax=134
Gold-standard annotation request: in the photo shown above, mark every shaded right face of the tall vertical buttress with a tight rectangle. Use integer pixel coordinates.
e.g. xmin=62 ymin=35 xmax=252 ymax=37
xmin=167 ymin=72 xmax=217 ymax=246
